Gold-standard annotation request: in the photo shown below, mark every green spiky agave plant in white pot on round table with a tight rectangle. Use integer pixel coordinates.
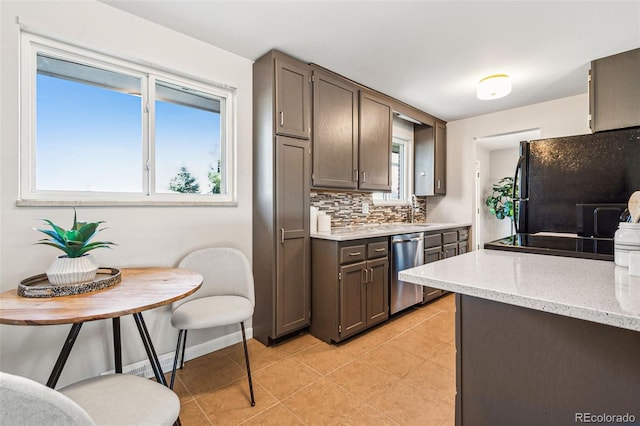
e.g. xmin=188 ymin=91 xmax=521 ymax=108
xmin=34 ymin=208 xmax=115 ymax=285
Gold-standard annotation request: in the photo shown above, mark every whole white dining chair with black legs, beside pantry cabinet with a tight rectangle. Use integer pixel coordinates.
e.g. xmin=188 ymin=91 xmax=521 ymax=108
xmin=169 ymin=247 xmax=255 ymax=406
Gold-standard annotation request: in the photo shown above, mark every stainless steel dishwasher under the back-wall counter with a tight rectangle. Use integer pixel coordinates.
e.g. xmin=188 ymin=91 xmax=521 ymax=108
xmin=389 ymin=232 xmax=424 ymax=314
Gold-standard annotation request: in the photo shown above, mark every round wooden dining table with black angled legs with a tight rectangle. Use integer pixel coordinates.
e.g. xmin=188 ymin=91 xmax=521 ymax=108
xmin=0 ymin=267 xmax=203 ymax=388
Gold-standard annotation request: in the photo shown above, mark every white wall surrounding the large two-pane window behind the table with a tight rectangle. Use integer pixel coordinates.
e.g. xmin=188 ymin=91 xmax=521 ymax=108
xmin=0 ymin=1 xmax=252 ymax=385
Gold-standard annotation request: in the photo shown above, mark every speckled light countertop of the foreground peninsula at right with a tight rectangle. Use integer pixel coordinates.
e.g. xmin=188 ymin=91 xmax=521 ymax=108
xmin=399 ymin=250 xmax=640 ymax=331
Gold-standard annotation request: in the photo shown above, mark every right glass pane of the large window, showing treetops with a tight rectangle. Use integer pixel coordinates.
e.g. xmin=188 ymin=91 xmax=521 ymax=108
xmin=155 ymin=82 xmax=226 ymax=194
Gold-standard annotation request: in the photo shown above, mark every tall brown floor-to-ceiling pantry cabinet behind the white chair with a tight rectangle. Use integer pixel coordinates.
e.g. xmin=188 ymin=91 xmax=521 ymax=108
xmin=253 ymin=51 xmax=311 ymax=345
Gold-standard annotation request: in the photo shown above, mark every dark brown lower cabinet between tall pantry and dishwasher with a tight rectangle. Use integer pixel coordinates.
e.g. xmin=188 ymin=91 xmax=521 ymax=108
xmin=311 ymin=237 xmax=389 ymax=343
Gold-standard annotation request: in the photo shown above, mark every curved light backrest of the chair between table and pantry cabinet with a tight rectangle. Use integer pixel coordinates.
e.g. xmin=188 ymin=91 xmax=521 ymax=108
xmin=172 ymin=247 xmax=255 ymax=309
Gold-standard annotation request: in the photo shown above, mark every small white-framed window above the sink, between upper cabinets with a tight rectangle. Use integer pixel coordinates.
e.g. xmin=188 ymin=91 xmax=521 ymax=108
xmin=373 ymin=119 xmax=413 ymax=205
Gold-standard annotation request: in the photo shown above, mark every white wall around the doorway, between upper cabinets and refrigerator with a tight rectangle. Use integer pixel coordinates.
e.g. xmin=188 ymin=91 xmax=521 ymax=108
xmin=428 ymin=93 xmax=590 ymax=245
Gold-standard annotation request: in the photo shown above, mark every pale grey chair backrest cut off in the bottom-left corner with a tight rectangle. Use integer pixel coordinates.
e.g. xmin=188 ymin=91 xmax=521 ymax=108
xmin=0 ymin=372 xmax=95 ymax=426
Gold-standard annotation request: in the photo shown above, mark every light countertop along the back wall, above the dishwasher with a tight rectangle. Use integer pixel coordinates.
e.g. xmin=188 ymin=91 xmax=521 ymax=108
xmin=311 ymin=222 xmax=471 ymax=241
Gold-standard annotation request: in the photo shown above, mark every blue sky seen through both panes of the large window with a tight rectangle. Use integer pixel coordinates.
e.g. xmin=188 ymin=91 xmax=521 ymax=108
xmin=36 ymin=74 xmax=221 ymax=193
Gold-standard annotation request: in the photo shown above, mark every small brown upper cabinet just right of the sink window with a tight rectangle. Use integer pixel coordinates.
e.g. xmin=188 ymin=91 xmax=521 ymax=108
xmin=413 ymin=121 xmax=447 ymax=196
